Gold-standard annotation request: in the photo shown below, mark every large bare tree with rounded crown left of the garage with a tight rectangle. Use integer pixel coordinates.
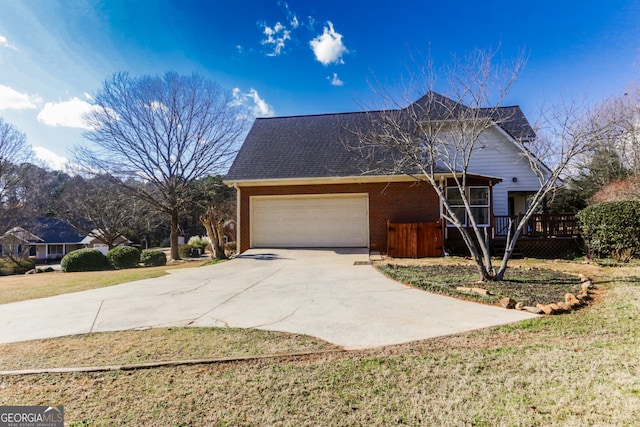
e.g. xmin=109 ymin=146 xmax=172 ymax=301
xmin=76 ymin=72 xmax=244 ymax=259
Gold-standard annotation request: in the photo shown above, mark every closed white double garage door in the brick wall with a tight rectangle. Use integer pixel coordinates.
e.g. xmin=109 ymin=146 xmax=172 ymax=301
xmin=251 ymin=194 xmax=369 ymax=248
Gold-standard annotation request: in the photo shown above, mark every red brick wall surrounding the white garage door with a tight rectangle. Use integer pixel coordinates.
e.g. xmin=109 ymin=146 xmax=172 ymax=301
xmin=239 ymin=182 xmax=440 ymax=253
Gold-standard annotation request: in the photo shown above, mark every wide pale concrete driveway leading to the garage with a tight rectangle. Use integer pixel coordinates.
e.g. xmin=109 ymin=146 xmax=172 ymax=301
xmin=0 ymin=249 xmax=536 ymax=349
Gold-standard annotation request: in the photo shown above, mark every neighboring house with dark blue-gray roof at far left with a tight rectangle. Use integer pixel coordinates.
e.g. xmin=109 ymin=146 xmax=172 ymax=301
xmin=0 ymin=218 xmax=128 ymax=261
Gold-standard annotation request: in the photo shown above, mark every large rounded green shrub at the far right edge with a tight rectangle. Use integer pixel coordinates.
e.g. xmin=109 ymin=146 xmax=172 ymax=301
xmin=576 ymin=201 xmax=640 ymax=262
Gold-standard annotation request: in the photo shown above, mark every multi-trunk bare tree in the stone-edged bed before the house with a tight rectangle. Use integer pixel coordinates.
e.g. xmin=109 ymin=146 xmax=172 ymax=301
xmin=347 ymin=51 xmax=584 ymax=280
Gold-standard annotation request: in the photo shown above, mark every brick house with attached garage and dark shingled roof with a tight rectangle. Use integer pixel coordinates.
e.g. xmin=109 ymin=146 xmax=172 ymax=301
xmin=225 ymin=93 xmax=538 ymax=253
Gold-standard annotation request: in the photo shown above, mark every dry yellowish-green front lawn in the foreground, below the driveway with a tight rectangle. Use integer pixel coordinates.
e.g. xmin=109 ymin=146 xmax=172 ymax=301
xmin=0 ymin=262 xmax=640 ymax=427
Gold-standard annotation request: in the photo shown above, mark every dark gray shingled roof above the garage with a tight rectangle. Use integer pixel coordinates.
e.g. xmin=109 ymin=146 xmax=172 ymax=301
xmin=225 ymin=94 xmax=534 ymax=181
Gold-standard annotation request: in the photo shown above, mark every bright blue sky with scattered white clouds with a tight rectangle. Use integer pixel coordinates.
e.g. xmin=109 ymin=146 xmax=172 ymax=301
xmin=0 ymin=0 xmax=640 ymax=171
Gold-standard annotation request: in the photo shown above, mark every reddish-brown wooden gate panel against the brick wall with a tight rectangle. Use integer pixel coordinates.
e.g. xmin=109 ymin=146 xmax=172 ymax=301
xmin=387 ymin=220 xmax=443 ymax=258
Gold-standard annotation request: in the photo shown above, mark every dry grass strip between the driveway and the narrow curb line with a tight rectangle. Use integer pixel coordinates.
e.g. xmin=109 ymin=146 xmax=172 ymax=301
xmin=0 ymin=327 xmax=336 ymax=370
